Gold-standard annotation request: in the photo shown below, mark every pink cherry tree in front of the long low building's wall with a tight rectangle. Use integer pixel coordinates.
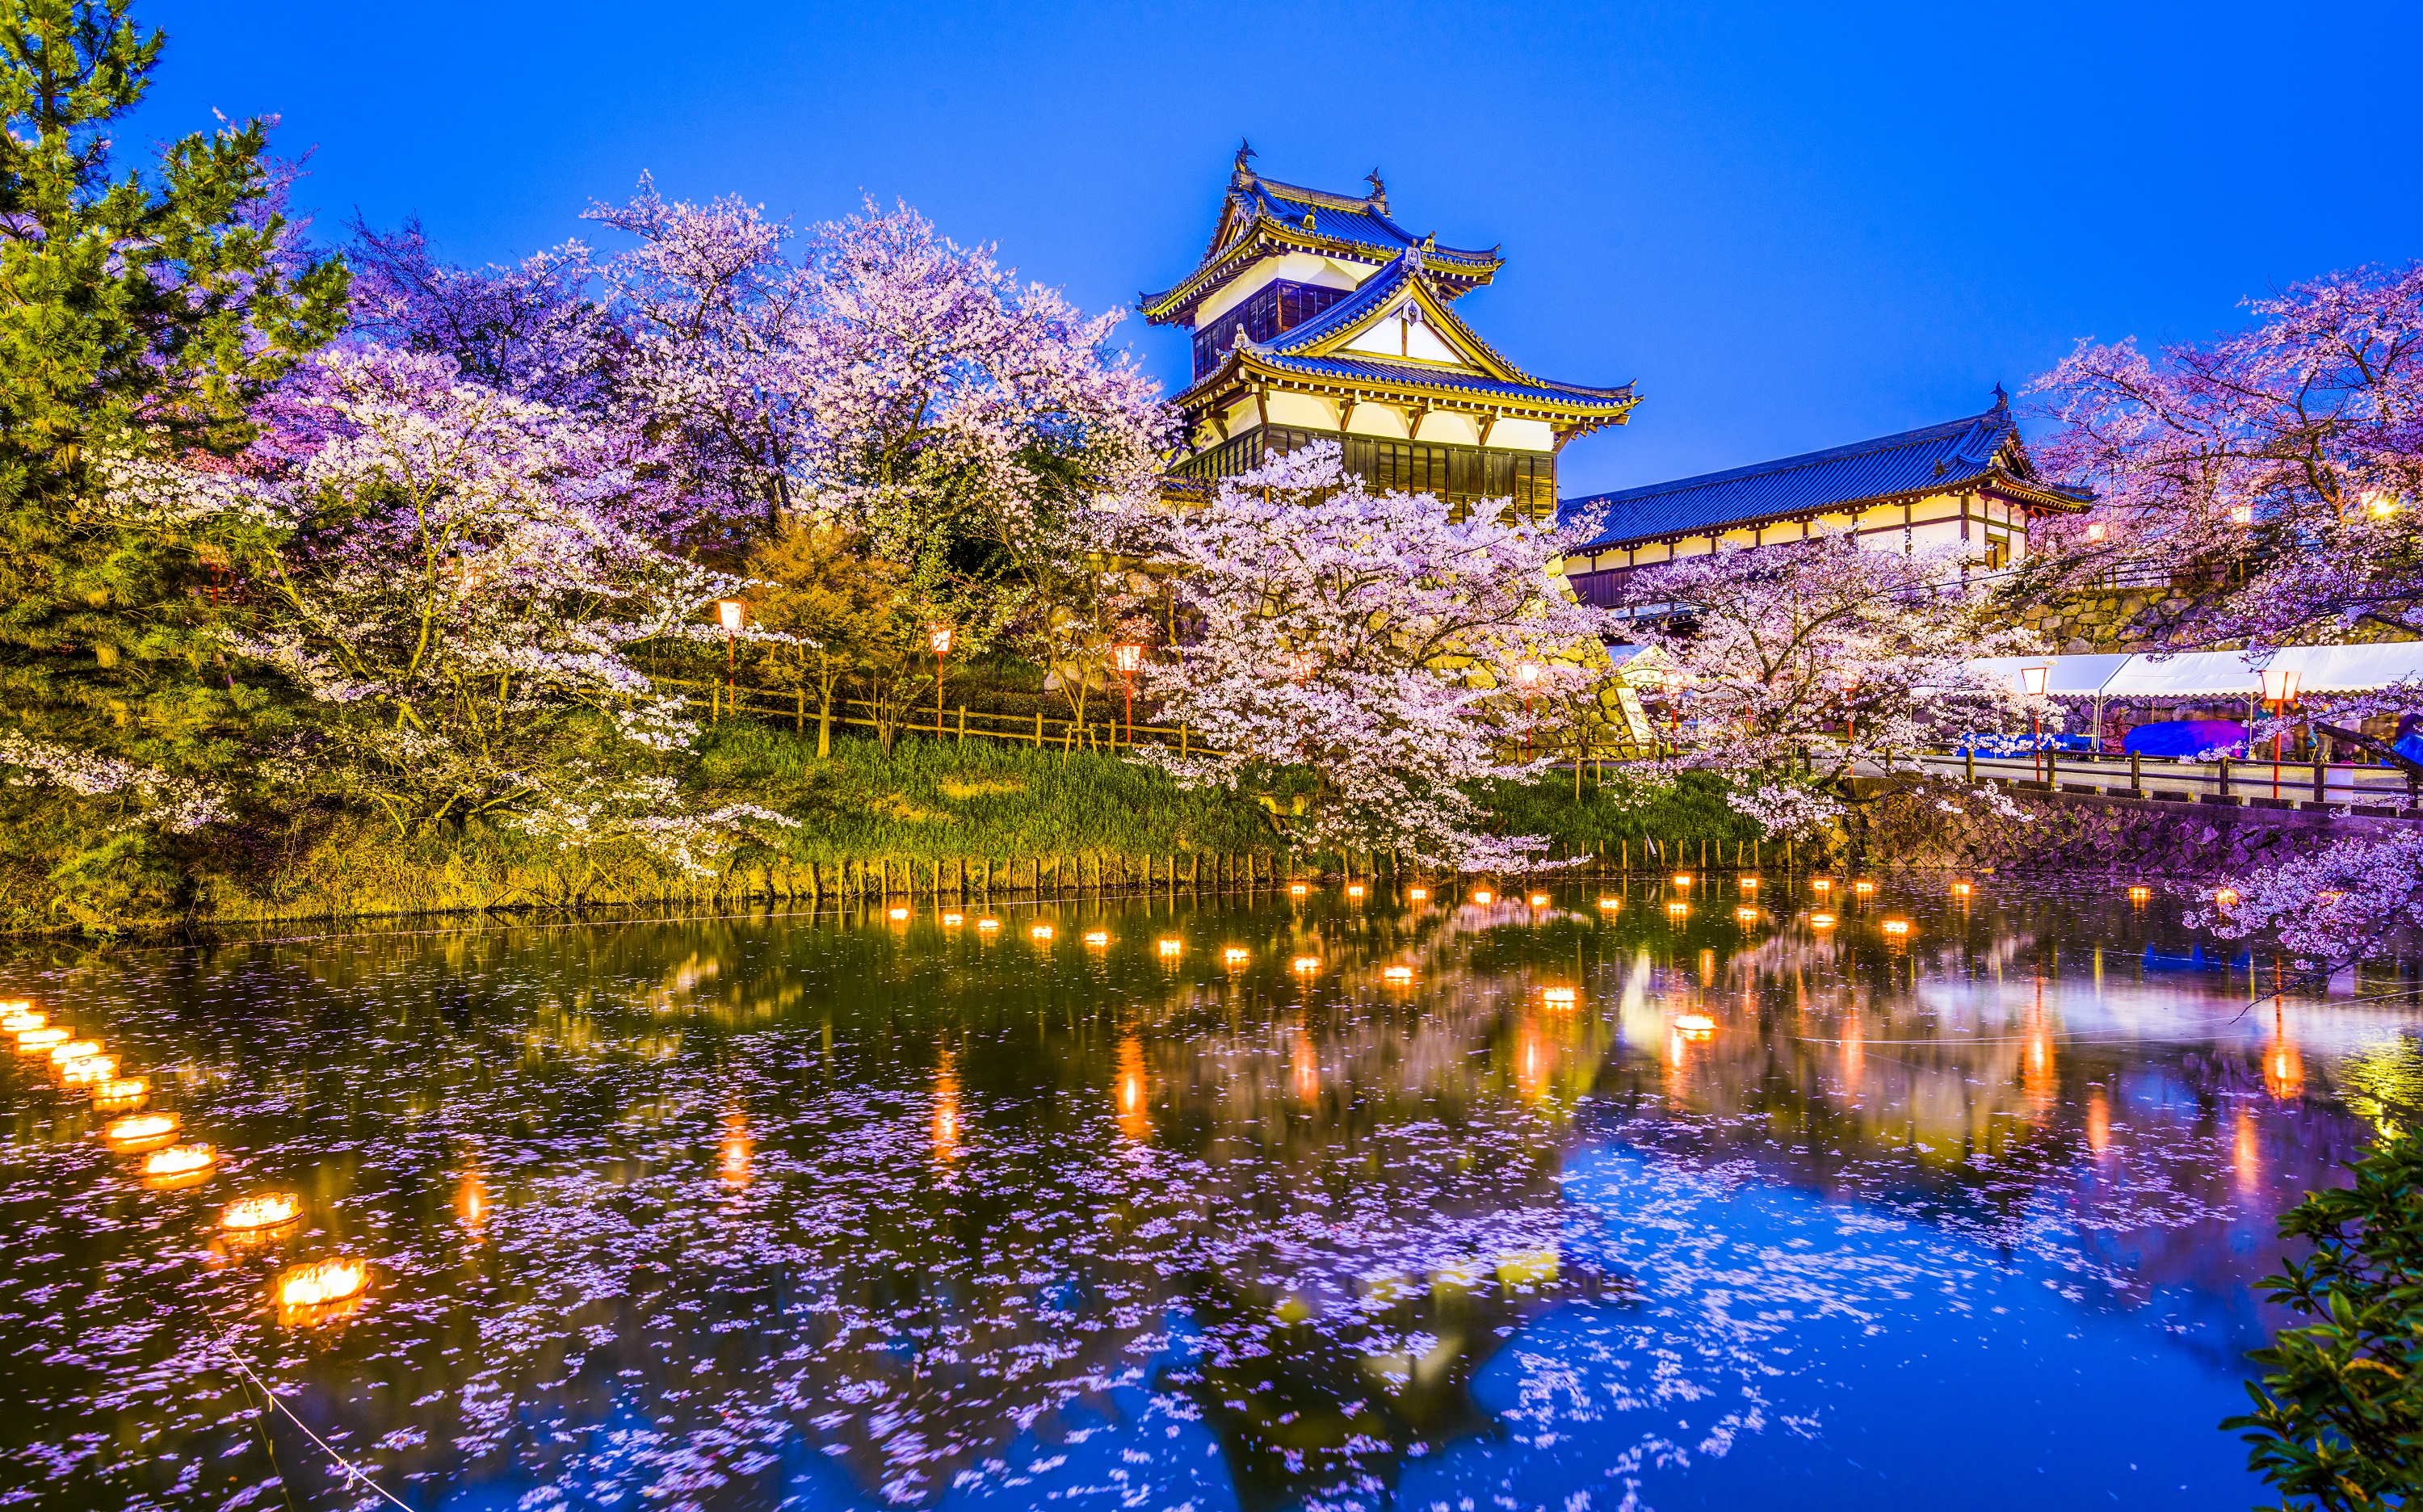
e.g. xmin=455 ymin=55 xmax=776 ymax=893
xmin=1623 ymin=533 xmax=2040 ymax=838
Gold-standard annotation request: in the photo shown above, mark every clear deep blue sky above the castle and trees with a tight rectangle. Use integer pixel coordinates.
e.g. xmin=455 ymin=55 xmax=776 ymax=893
xmin=141 ymin=0 xmax=2423 ymax=494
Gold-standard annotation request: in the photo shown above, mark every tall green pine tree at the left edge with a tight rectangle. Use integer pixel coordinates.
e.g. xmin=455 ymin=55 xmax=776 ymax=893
xmin=0 ymin=0 xmax=346 ymax=906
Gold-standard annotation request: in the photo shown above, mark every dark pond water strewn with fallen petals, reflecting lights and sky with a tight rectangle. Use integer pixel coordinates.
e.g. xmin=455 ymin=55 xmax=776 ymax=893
xmin=0 ymin=882 xmax=2418 ymax=1512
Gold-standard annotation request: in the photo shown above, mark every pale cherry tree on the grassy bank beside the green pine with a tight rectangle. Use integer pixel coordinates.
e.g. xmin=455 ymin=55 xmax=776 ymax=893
xmin=111 ymin=346 xmax=787 ymax=867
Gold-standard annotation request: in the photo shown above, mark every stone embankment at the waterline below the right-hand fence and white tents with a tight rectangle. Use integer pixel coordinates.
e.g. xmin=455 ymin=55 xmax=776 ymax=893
xmin=1854 ymin=783 xmax=2423 ymax=877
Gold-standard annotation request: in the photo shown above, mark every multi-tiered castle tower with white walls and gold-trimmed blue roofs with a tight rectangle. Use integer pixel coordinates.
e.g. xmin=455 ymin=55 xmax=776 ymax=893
xmin=1139 ymin=148 xmax=1636 ymax=519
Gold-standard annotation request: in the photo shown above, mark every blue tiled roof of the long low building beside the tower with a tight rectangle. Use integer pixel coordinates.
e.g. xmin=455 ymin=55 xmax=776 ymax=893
xmin=1558 ymin=402 xmax=2086 ymax=550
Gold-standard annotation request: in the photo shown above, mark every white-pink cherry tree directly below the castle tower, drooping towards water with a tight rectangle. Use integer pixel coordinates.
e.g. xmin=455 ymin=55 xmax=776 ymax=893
xmin=1139 ymin=441 xmax=1604 ymax=870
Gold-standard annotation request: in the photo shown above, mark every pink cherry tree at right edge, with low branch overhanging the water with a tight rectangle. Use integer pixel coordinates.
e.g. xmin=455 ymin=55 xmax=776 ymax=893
xmin=2033 ymin=262 xmax=2423 ymax=969
